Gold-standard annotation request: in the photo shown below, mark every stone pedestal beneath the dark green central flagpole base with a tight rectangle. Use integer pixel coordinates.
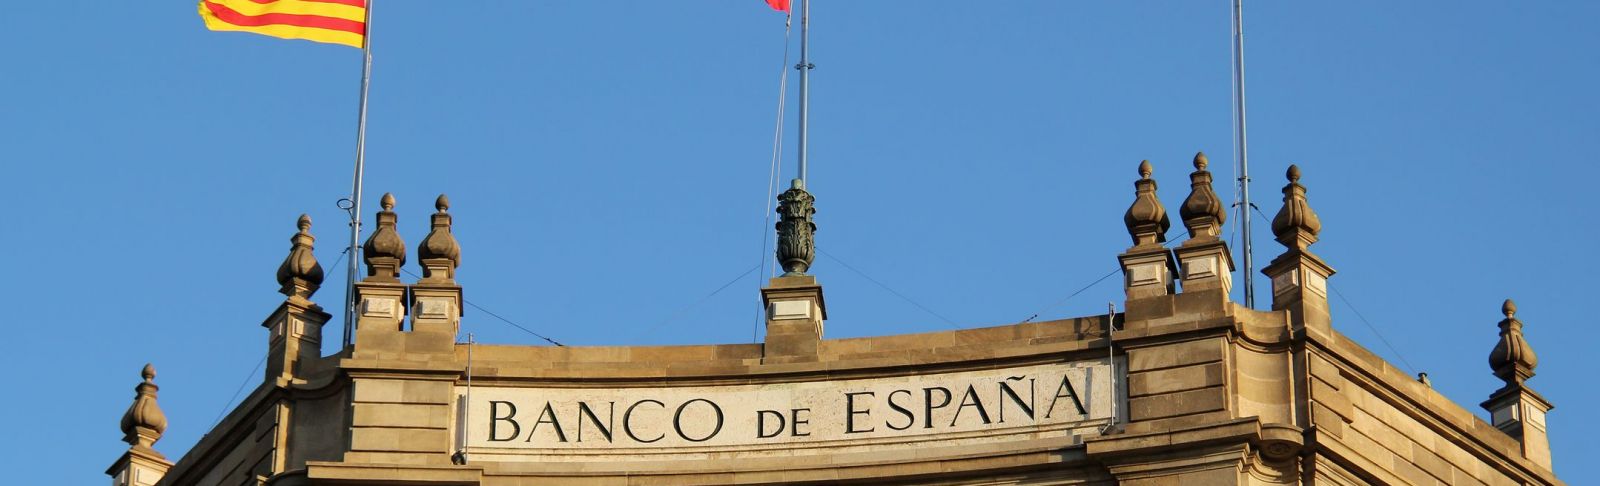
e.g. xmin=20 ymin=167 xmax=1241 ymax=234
xmin=762 ymin=275 xmax=827 ymax=363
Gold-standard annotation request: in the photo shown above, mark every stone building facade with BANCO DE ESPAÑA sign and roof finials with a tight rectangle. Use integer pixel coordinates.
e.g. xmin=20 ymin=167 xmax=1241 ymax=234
xmin=107 ymin=155 xmax=1562 ymax=486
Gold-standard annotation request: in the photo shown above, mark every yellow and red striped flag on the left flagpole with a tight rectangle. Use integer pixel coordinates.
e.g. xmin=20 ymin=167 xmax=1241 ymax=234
xmin=200 ymin=0 xmax=368 ymax=48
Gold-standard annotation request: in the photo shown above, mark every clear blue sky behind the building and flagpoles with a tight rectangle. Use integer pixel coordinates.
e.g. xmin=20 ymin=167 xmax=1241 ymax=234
xmin=0 ymin=0 xmax=1600 ymax=484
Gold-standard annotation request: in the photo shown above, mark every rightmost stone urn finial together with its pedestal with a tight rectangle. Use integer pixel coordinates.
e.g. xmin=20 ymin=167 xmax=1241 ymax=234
xmin=1482 ymin=299 xmax=1555 ymax=468
